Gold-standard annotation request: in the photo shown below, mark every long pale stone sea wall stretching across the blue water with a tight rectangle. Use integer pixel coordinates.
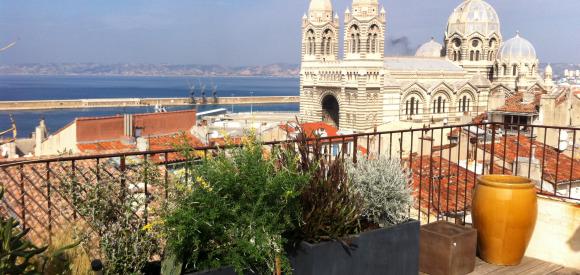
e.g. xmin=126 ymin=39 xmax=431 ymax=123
xmin=0 ymin=96 xmax=300 ymax=111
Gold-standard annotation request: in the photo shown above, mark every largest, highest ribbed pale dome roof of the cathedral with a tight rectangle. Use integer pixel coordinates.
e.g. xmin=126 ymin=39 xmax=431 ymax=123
xmin=447 ymin=0 xmax=501 ymax=36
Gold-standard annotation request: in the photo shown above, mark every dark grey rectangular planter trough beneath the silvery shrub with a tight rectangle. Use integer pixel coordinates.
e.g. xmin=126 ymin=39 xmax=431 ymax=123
xmin=288 ymin=221 xmax=419 ymax=275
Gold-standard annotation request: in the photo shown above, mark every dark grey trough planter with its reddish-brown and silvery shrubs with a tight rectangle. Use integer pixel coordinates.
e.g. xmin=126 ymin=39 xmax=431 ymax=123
xmin=288 ymin=132 xmax=419 ymax=275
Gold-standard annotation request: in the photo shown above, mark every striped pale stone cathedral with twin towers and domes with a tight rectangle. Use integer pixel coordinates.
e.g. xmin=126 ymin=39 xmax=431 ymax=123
xmin=300 ymin=0 xmax=551 ymax=132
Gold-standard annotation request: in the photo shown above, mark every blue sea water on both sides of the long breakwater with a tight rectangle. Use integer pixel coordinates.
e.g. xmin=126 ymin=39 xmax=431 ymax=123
xmin=0 ymin=76 xmax=300 ymax=138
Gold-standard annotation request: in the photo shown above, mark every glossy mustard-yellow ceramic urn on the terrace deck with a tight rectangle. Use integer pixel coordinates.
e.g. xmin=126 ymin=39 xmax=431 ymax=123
xmin=472 ymin=175 xmax=538 ymax=265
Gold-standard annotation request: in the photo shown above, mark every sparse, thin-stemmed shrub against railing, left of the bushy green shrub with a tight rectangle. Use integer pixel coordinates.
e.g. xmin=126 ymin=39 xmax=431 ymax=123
xmin=59 ymin=162 xmax=163 ymax=274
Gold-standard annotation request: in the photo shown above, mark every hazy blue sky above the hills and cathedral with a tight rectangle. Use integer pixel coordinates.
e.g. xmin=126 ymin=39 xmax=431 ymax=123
xmin=0 ymin=0 xmax=580 ymax=65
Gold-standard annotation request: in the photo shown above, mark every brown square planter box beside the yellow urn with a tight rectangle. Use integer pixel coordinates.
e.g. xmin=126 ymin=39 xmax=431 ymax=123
xmin=419 ymin=221 xmax=477 ymax=275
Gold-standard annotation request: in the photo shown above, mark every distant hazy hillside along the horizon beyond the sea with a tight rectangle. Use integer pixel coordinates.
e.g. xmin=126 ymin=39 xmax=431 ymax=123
xmin=0 ymin=63 xmax=300 ymax=77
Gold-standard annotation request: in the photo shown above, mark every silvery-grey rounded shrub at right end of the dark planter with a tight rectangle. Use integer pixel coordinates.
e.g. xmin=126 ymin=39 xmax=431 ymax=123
xmin=347 ymin=156 xmax=413 ymax=227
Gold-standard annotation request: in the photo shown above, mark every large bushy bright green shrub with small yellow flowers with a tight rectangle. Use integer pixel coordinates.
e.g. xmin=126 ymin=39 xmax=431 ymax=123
xmin=164 ymin=138 xmax=308 ymax=274
